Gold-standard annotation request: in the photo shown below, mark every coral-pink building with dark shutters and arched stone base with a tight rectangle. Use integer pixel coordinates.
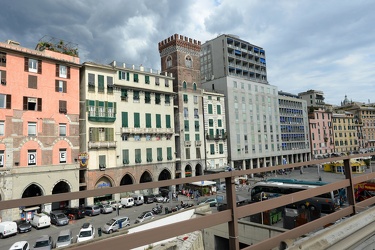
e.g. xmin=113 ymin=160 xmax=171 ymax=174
xmin=0 ymin=38 xmax=80 ymax=220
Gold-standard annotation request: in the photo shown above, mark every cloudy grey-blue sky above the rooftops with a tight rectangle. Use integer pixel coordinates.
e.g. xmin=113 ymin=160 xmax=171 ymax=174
xmin=0 ymin=0 xmax=375 ymax=105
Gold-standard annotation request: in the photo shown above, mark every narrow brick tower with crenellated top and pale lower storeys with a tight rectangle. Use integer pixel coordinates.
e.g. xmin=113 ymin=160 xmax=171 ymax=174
xmin=158 ymin=34 xmax=206 ymax=181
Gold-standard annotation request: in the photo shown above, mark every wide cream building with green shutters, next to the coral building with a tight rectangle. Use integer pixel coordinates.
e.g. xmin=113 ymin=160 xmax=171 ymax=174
xmin=80 ymin=61 xmax=175 ymax=204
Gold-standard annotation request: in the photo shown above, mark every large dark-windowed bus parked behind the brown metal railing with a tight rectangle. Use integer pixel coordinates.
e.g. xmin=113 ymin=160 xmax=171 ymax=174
xmin=251 ymin=179 xmax=340 ymax=213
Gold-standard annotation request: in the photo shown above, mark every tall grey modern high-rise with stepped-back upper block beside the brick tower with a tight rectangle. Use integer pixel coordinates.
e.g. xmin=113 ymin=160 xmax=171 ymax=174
xmin=201 ymin=35 xmax=283 ymax=169
